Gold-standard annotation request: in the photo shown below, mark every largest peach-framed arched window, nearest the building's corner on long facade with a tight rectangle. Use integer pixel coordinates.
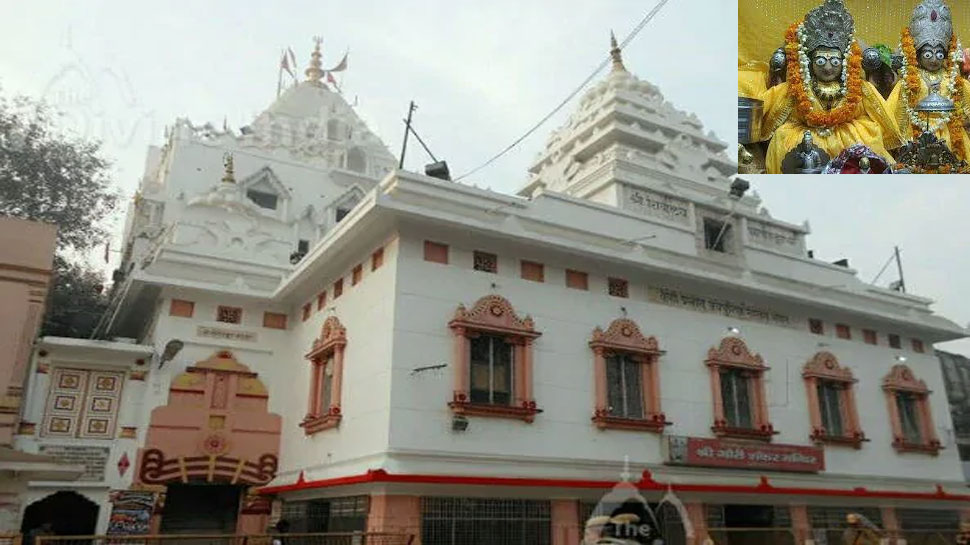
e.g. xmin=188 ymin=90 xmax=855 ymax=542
xmin=448 ymin=295 xmax=542 ymax=422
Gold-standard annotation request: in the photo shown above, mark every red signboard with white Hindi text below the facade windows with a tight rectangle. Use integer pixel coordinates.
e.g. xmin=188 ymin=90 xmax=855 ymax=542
xmin=667 ymin=436 xmax=825 ymax=473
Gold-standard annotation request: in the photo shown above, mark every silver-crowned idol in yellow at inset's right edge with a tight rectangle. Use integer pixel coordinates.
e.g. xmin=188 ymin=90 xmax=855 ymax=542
xmin=887 ymin=0 xmax=970 ymax=161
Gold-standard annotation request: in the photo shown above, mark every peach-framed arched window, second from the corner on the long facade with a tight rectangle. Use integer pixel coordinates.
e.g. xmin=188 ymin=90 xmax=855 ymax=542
xmin=589 ymin=318 xmax=670 ymax=432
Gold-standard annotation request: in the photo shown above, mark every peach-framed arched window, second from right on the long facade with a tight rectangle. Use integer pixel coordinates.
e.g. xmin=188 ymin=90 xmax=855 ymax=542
xmin=802 ymin=352 xmax=867 ymax=448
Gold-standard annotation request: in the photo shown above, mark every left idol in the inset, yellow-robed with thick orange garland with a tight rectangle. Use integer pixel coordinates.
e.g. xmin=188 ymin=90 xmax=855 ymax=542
xmin=760 ymin=0 xmax=902 ymax=174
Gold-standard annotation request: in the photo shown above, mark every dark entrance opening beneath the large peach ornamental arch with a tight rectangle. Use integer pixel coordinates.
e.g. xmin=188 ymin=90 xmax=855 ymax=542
xmin=161 ymin=484 xmax=243 ymax=534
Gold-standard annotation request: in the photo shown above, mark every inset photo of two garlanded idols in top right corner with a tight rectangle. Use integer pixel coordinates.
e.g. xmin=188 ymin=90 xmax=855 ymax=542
xmin=738 ymin=0 xmax=970 ymax=174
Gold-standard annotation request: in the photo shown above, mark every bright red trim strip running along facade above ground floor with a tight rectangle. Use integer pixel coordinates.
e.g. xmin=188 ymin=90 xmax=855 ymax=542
xmin=259 ymin=469 xmax=970 ymax=501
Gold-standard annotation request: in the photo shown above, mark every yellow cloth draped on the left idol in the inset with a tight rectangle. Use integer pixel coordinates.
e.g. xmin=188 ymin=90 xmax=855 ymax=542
xmin=760 ymin=81 xmax=902 ymax=174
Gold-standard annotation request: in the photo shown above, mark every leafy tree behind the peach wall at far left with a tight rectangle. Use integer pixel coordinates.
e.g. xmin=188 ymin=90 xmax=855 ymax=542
xmin=0 ymin=89 xmax=118 ymax=337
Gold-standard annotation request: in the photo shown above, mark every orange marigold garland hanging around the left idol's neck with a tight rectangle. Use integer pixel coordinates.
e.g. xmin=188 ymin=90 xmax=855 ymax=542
xmin=785 ymin=23 xmax=862 ymax=129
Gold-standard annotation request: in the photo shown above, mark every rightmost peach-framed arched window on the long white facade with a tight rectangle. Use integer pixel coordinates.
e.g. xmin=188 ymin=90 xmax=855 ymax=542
xmin=882 ymin=364 xmax=943 ymax=455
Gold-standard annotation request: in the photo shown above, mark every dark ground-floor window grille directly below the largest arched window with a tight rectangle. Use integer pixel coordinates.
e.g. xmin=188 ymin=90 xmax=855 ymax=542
xmin=421 ymin=498 xmax=552 ymax=545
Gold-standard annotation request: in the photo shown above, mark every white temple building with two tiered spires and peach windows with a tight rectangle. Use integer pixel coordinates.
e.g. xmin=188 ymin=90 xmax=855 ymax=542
xmin=9 ymin=37 xmax=970 ymax=545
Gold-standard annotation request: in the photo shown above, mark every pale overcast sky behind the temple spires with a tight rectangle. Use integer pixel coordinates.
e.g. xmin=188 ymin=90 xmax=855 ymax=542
xmin=0 ymin=0 xmax=970 ymax=355
